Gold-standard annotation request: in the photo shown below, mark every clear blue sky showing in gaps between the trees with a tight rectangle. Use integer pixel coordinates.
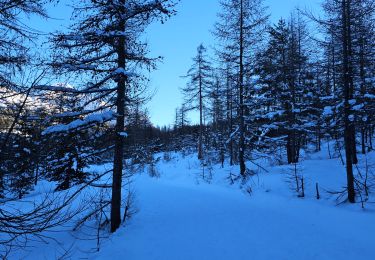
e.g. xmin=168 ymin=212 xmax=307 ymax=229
xmin=31 ymin=0 xmax=321 ymax=126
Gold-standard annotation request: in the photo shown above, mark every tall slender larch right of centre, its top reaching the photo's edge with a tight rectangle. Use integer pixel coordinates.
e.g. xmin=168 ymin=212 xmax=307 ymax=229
xmin=214 ymin=0 xmax=268 ymax=176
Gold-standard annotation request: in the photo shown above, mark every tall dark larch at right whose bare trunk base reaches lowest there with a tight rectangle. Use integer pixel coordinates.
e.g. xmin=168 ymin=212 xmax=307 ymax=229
xmin=315 ymin=0 xmax=375 ymax=203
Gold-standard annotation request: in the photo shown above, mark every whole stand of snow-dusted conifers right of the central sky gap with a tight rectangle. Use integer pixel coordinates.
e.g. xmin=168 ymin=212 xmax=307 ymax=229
xmin=176 ymin=0 xmax=375 ymax=202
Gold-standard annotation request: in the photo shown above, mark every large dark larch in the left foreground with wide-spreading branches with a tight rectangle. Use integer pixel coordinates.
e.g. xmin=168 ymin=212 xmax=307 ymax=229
xmin=49 ymin=0 xmax=175 ymax=232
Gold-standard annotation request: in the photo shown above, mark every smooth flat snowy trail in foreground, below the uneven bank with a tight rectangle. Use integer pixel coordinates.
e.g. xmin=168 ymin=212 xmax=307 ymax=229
xmin=95 ymin=177 xmax=375 ymax=260
